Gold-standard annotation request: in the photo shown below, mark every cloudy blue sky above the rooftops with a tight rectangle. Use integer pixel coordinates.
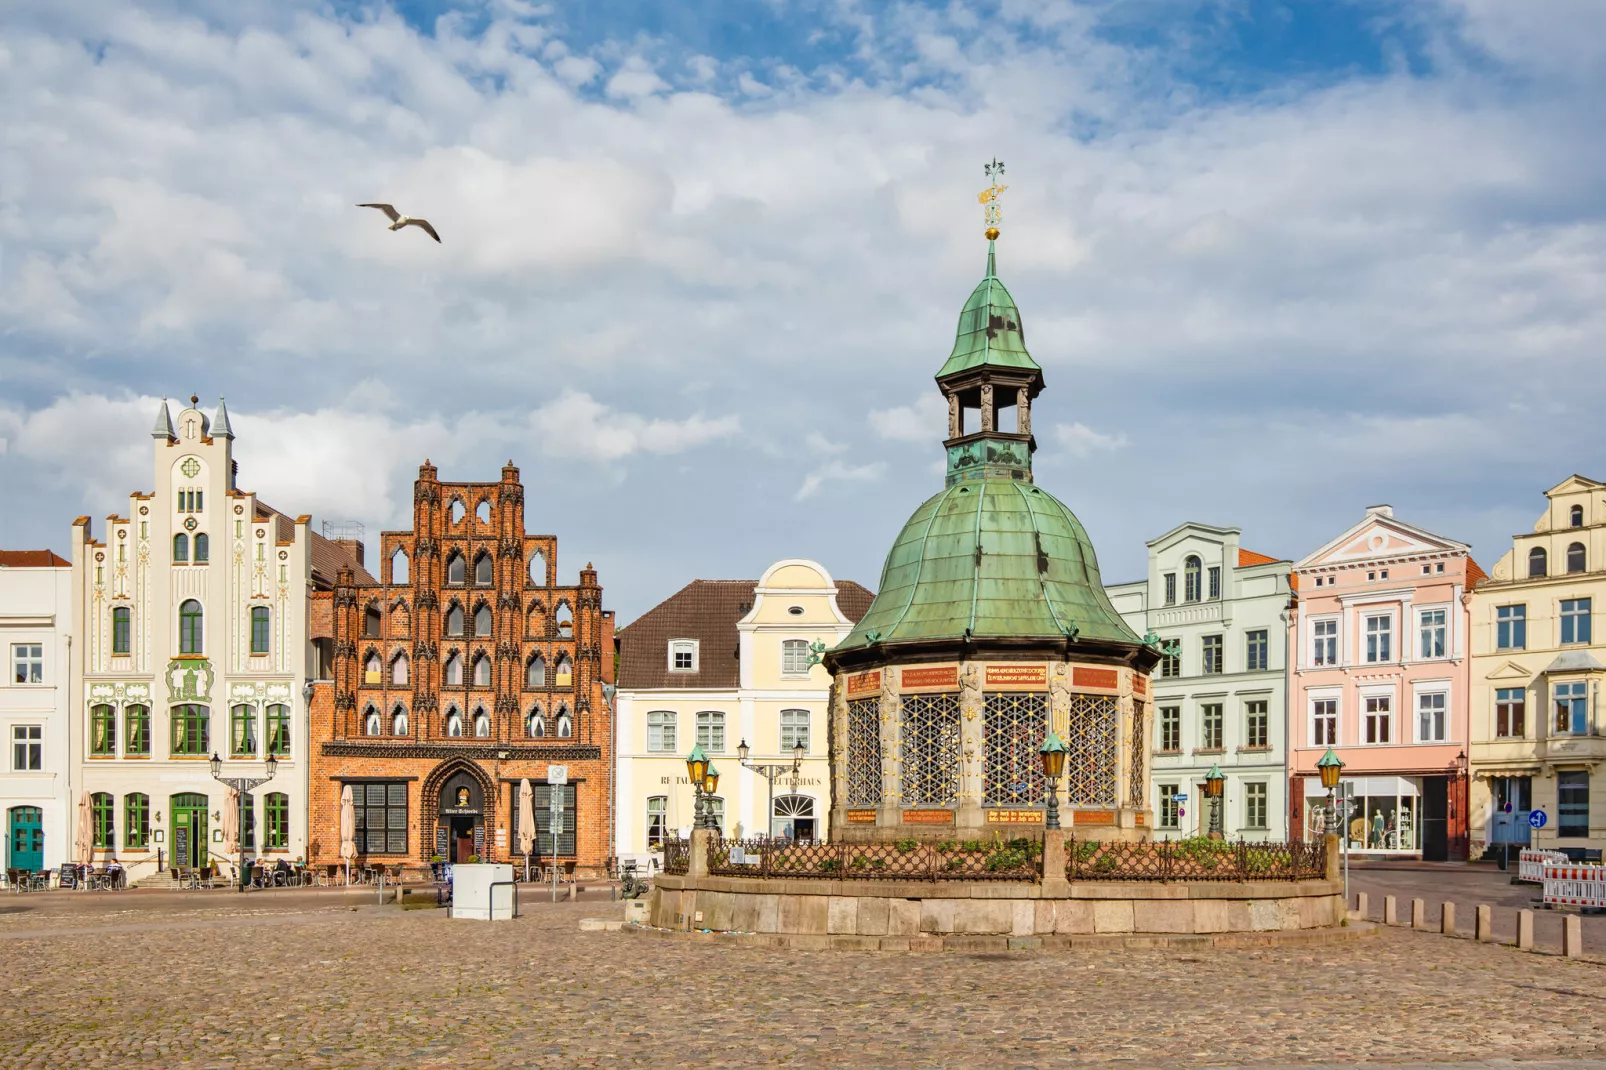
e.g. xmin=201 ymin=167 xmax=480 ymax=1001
xmin=0 ymin=0 xmax=1606 ymax=623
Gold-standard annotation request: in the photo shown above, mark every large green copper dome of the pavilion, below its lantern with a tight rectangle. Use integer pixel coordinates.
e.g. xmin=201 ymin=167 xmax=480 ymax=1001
xmin=837 ymin=479 xmax=1140 ymax=651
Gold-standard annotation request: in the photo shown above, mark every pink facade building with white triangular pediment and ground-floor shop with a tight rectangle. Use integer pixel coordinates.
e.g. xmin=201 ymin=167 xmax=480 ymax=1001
xmin=1288 ymin=506 xmax=1484 ymax=860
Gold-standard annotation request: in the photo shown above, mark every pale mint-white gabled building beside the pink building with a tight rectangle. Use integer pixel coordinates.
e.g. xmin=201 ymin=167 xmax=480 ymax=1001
xmin=1105 ymin=524 xmax=1293 ymax=840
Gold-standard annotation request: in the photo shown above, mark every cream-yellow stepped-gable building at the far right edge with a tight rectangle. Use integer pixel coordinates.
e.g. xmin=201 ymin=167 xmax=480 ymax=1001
xmin=1471 ymin=476 xmax=1606 ymax=852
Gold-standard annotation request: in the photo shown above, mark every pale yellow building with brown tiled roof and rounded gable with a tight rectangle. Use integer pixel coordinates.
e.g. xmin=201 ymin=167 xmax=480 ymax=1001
xmin=615 ymin=559 xmax=870 ymax=871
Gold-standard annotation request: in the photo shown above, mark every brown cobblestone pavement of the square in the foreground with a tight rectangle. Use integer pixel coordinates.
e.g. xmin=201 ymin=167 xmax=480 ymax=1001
xmin=0 ymin=893 xmax=1606 ymax=1070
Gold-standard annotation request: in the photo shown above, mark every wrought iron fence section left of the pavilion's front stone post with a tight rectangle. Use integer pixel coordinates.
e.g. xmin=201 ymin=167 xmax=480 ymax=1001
xmin=708 ymin=839 xmax=1042 ymax=880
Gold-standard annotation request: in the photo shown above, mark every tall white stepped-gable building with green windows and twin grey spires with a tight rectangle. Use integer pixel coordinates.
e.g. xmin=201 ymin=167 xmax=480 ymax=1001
xmin=72 ymin=398 xmax=361 ymax=879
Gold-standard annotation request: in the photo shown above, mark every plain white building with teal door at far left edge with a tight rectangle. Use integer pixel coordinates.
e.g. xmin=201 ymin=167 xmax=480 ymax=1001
xmin=0 ymin=549 xmax=72 ymax=871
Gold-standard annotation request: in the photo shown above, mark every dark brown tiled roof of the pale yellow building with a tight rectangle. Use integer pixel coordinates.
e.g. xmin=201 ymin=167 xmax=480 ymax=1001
xmin=618 ymin=580 xmax=875 ymax=691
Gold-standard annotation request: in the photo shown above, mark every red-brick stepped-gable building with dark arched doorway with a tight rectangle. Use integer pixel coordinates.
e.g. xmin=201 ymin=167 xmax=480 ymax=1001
xmin=308 ymin=461 xmax=613 ymax=874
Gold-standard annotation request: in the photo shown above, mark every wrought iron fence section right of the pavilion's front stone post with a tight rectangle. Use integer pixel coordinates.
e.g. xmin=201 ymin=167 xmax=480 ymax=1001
xmin=1065 ymin=837 xmax=1327 ymax=882
